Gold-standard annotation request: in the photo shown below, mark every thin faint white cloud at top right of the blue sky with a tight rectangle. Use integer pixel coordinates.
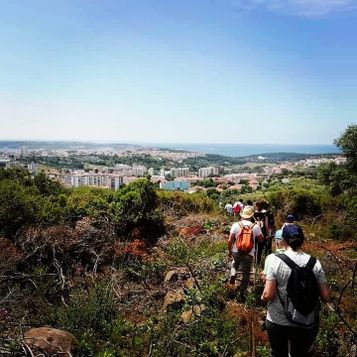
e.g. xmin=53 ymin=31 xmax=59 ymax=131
xmin=234 ymin=0 xmax=357 ymax=17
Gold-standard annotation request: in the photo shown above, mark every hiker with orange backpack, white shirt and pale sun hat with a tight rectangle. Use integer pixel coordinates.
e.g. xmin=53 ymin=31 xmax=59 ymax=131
xmin=228 ymin=206 xmax=263 ymax=302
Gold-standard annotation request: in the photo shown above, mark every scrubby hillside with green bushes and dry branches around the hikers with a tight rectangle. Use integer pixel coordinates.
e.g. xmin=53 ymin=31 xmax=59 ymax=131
xmin=0 ymin=165 xmax=357 ymax=357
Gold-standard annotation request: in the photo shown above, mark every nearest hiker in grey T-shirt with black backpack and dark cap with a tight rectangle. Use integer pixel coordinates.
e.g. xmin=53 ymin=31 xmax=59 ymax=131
xmin=261 ymin=224 xmax=330 ymax=357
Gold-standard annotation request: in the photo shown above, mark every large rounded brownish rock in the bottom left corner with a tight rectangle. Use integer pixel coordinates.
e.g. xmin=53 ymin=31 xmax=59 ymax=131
xmin=24 ymin=327 xmax=77 ymax=357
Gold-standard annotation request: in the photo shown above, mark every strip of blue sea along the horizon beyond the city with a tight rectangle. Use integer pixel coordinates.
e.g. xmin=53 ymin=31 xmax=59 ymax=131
xmin=155 ymin=143 xmax=340 ymax=157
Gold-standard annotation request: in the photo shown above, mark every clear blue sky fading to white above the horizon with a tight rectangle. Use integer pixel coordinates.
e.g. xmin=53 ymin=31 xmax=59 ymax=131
xmin=0 ymin=0 xmax=357 ymax=144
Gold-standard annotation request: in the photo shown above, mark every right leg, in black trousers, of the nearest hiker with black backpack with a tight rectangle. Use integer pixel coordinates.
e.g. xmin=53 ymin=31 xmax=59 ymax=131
xmin=289 ymin=325 xmax=318 ymax=357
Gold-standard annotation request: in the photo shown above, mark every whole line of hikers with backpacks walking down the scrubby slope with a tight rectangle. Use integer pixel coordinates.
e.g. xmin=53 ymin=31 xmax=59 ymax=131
xmin=225 ymin=200 xmax=330 ymax=357
